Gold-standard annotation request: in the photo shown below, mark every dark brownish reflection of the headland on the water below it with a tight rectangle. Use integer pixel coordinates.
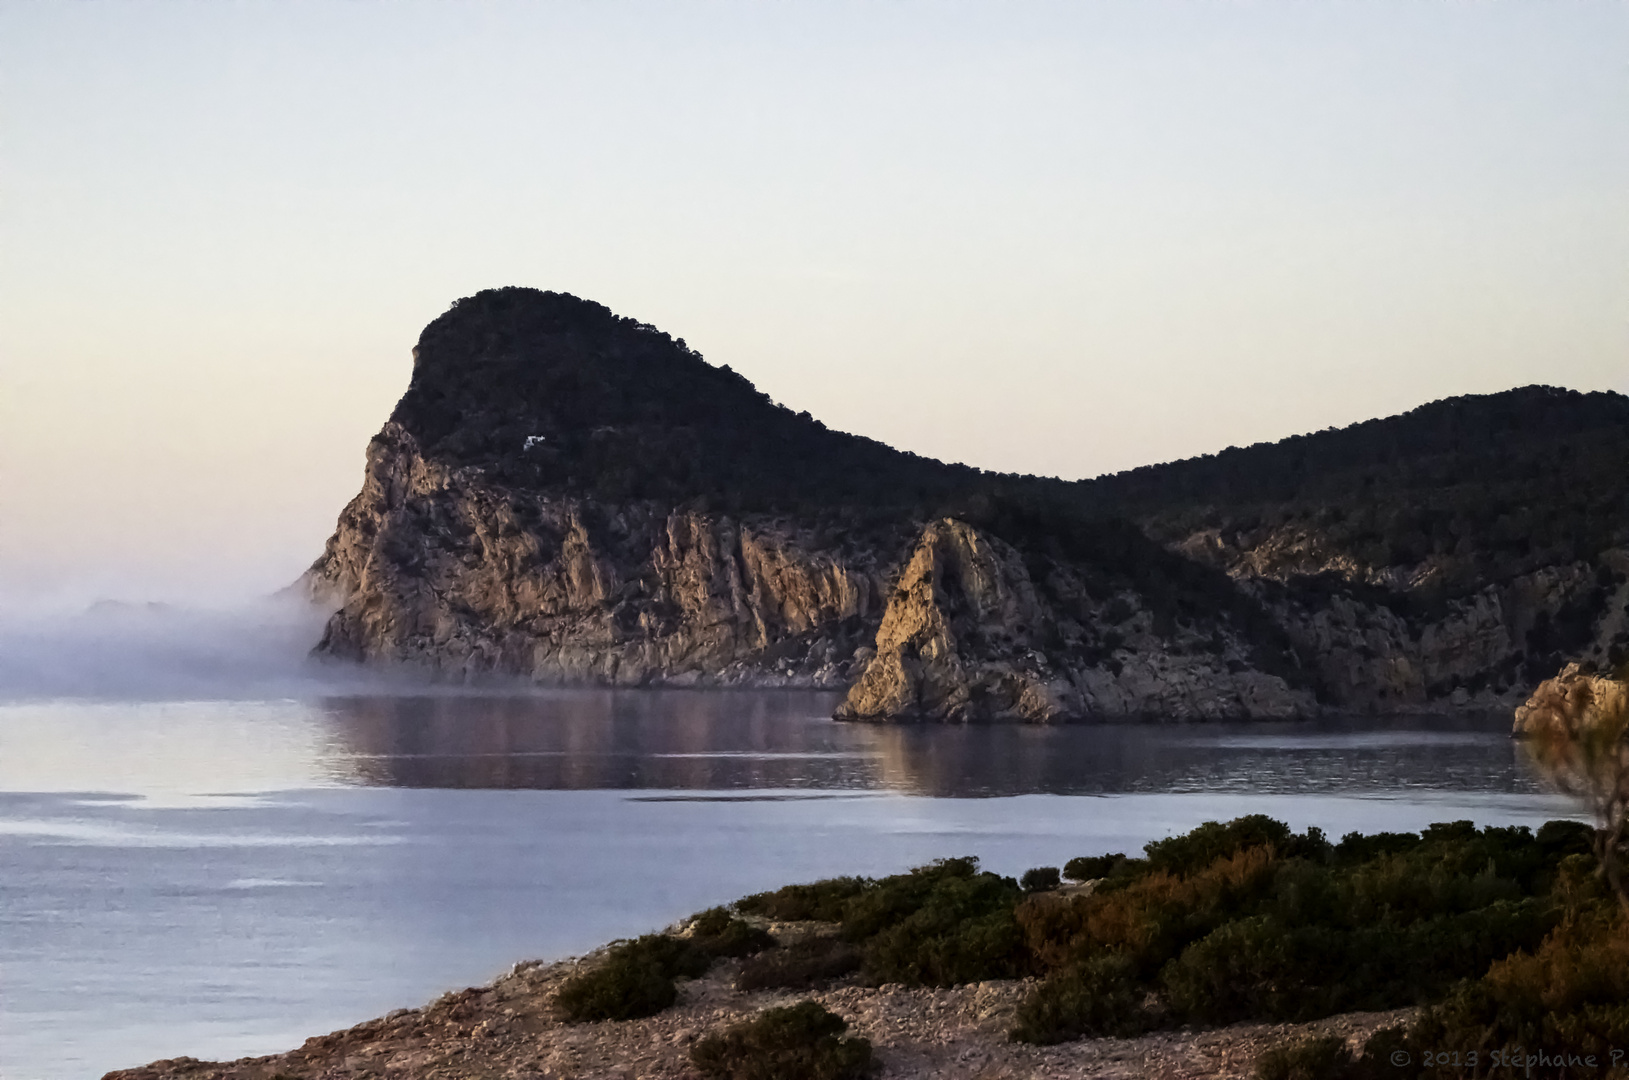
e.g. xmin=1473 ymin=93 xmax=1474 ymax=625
xmin=323 ymin=691 xmax=1539 ymax=797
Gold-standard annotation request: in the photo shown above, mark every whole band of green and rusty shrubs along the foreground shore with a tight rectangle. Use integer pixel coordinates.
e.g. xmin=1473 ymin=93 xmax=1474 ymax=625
xmin=570 ymin=814 xmax=1602 ymax=1055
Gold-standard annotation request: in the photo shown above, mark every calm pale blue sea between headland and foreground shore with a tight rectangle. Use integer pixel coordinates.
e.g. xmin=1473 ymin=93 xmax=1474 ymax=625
xmin=0 ymin=692 xmax=1572 ymax=1080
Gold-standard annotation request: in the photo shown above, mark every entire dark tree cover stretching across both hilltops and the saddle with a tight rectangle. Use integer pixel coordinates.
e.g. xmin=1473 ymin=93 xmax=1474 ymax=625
xmin=400 ymin=287 xmax=1629 ymax=573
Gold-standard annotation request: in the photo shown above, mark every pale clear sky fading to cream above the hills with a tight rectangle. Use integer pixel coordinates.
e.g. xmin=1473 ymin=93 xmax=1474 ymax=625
xmin=0 ymin=0 xmax=1629 ymax=609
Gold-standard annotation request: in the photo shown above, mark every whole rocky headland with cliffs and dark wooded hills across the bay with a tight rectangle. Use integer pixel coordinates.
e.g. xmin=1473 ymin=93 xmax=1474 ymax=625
xmin=303 ymin=288 xmax=1629 ymax=722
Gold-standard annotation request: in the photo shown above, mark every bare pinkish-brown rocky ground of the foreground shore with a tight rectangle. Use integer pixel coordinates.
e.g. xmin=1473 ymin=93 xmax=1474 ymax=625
xmin=104 ymin=924 xmax=1412 ymax=1080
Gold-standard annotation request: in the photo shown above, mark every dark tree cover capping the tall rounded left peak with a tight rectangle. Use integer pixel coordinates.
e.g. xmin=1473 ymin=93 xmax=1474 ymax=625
xmin=391 ymin=288 xmax=1009 ymax=513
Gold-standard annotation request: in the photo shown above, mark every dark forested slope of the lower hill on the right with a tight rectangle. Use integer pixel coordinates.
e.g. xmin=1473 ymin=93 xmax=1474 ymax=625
xmin=1085 ymin=386 xmax=1629 ymax=590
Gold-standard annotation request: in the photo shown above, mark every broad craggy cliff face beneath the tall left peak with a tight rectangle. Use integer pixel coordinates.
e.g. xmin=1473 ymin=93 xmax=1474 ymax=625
xmin=305 ymin=424 xmax=891 ymax=687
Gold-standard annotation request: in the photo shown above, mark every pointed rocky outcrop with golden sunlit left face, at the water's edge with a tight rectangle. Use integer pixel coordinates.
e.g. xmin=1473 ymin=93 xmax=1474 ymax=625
xmin=837 ymin=518 xmax=1318 ymax=723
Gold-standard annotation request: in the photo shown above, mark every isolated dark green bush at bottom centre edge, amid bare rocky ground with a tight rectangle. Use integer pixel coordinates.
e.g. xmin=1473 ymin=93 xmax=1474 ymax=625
xmin=691 ymin=1002 xmax=872 ymax=1080
